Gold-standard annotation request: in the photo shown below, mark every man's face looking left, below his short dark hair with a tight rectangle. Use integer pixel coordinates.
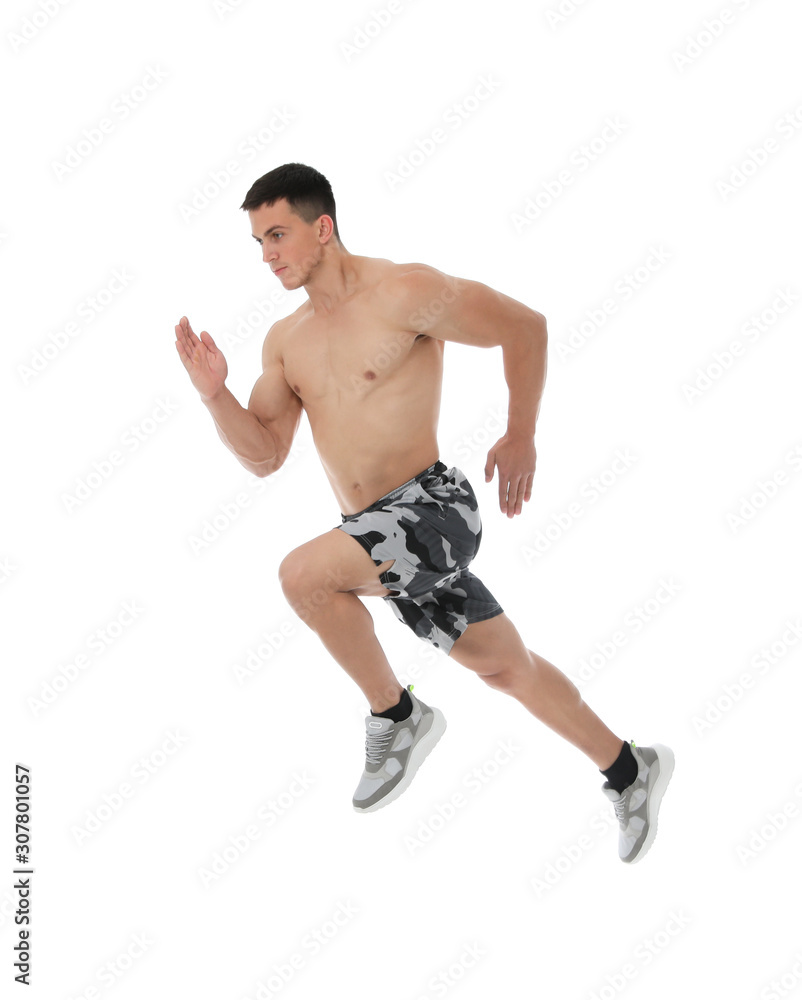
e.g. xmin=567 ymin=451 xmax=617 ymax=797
xmin=248 ymin=198 xmax=323 ymax=288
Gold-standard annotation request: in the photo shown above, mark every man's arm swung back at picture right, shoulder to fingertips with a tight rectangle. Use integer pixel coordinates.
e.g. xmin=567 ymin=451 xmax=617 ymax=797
xmin=386 ymin=265 xmax=548 ymax=517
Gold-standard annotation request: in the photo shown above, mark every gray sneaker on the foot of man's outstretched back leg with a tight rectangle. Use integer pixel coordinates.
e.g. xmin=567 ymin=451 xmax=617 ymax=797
xmin=602 ymin=740 xmax=674 ymax=864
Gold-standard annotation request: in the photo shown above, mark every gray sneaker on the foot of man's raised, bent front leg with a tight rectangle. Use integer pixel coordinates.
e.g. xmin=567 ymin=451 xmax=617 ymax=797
xmin=353 ymin=684 xmax=446 ymax=812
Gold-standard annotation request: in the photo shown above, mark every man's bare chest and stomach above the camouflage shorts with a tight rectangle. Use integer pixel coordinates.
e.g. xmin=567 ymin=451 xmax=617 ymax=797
xmin=281 ymin=258 xmax=445 ymax=514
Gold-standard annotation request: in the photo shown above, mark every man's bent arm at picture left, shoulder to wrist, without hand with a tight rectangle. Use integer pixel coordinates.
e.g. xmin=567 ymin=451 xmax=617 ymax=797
xmin=201 ymin=321 xmax=303 ymax=477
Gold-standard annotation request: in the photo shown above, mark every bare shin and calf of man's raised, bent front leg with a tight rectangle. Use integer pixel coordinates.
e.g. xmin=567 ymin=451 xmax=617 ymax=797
xmin=290 ymin=591 xmax=404 ymax=712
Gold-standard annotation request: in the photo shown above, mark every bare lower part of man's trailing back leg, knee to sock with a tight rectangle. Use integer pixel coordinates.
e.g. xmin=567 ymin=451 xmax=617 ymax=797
xmin=481 ymin=649 xmax=624 ymax=771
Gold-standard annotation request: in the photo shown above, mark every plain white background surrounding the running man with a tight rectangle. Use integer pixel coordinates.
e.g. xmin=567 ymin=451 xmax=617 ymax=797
xmin=0 ymin=0 xmax=802 ymax=1000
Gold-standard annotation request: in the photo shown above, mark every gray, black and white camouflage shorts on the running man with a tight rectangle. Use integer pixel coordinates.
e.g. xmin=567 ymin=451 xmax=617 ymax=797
xmin=337 ymin=461 xmax=504 ymax=654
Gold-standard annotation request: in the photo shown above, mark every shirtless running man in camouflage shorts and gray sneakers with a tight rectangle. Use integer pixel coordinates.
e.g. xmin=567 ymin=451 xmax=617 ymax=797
xmin=175 ymin=163 xmax=674 ymax=863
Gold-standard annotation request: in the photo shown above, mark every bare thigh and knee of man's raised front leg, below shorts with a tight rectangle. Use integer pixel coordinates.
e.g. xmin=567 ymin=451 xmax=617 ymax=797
xmin=278 ymin=528 xmax=395 ymax=597
